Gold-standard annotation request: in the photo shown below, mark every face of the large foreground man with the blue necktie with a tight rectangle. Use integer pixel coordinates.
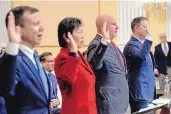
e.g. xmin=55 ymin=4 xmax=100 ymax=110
xmin=21 ymin=11 xmax=44 ymax=47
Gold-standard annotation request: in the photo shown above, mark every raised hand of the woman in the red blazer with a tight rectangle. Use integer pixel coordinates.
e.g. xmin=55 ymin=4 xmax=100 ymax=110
xmin=67 ymin=32 xmax=78 ymax=53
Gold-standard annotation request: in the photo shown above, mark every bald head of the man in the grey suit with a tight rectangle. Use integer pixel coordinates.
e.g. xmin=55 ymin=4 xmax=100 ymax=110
xmin=96 ymin=15 xmax=118 ymax=40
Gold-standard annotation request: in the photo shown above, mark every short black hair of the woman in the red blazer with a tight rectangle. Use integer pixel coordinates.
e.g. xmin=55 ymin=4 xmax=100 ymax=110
xmin=58 ymin=17 xmax=82 ymax=48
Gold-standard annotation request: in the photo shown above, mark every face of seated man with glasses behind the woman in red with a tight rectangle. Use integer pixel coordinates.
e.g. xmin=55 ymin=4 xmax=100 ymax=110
xmin=42 ymin=55 xmax=54 ymax=72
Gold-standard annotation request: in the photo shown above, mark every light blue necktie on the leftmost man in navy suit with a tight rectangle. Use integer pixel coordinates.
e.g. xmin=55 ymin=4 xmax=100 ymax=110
xmin=34 ymin=52 xmax=49 ymax=98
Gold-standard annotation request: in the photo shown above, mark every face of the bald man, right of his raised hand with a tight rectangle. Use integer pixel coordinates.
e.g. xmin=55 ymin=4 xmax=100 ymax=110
xmin=107 ymin=17 xmax=119 ymax=40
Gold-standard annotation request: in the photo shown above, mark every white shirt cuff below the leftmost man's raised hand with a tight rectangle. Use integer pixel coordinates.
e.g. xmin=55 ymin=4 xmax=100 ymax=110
xmin=6 ymin=42 xmax=19 ymax=56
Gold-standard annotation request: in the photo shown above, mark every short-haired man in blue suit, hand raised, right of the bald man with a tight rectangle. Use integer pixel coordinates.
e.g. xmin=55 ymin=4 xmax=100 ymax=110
xmin=123 ymin=17 xmax=155 ymax=113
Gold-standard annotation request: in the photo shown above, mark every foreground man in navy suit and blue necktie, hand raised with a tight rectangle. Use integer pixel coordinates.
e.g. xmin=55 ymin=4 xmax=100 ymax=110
xmin=0 ymin=6 xmax=50 ymax=114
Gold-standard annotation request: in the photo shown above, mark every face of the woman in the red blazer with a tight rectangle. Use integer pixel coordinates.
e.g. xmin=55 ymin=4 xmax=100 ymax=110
xmin=72 ymin=26 xmax=84 ymax=48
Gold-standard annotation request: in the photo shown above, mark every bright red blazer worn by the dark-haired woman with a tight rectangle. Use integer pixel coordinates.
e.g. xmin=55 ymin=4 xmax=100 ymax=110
xmin=55 ymin=48 xmax=97 ymax=114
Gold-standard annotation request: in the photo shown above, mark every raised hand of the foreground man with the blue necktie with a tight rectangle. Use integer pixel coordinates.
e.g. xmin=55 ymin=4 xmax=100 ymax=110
xmin=7 ymin=12 xmax=21 ymax=44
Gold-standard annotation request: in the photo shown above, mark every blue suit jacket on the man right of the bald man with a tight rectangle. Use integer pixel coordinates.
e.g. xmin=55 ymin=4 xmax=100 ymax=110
xmin=124 ymin=37 xmax=155 ymax=102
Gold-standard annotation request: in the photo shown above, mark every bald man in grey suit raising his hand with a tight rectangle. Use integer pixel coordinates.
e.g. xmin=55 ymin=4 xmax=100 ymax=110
xmin=87 ymin=15 xmax=129 ymax=114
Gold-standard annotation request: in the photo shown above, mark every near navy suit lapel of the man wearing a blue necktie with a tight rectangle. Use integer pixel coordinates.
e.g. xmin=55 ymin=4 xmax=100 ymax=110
xmin=19 ymin=51 xmax=47 ymax=98
